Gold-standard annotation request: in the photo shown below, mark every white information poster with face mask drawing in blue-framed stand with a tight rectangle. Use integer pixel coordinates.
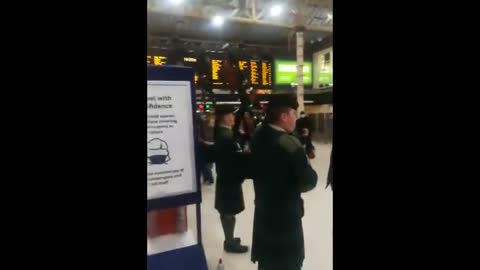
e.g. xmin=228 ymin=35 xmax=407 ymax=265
xmin=147 ymin=81 xmax=197 ymax=199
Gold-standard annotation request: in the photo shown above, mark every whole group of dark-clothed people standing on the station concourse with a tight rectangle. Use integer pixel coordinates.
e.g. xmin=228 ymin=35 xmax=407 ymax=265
xmin=196 ymin=96 xmax=333 ymax=270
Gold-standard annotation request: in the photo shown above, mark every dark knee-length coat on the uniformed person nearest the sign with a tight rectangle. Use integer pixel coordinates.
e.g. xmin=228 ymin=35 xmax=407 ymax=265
xmin=214 ymin=127 xmax=247 ymax=215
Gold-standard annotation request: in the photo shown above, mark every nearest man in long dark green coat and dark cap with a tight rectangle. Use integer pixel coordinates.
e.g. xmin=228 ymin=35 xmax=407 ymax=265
xmin=251 ymin=96 xmax=317 ymax=270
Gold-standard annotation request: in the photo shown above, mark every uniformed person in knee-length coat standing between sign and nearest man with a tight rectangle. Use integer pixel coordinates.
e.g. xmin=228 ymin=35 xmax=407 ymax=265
xmin=214 ymin=106 xmax=248 ymax=253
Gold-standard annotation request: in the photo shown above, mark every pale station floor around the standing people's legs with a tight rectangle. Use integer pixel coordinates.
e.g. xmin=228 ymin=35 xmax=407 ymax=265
xmin=188 ymin=143 xmax=333 ymax=270
